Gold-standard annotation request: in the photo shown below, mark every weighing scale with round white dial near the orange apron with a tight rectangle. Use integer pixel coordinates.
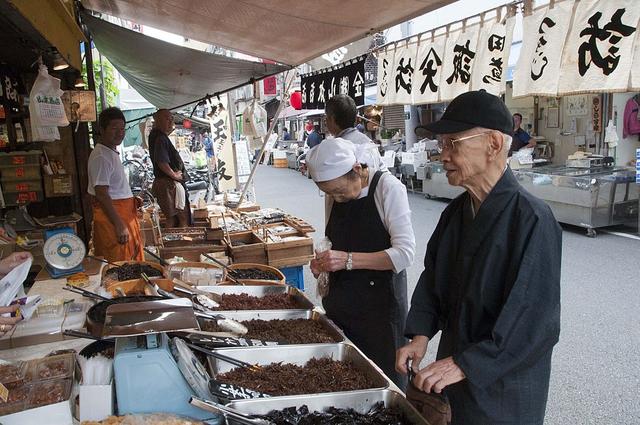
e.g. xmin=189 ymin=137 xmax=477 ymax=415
xmin=43 ymin=227 xmax=87 ymax=279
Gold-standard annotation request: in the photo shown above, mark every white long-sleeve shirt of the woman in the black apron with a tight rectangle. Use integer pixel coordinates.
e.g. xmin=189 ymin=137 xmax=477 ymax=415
xmin=325 ymin=170 xmax=416 ymax=273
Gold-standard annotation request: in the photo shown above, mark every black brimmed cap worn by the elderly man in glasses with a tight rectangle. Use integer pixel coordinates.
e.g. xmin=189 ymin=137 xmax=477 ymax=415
xmin=415 ymin=90 xmax=513 ymax=136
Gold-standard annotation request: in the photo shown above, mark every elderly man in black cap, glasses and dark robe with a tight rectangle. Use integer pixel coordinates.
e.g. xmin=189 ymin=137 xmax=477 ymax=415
xmin=396 ymin=91 xmax=562 ymax=425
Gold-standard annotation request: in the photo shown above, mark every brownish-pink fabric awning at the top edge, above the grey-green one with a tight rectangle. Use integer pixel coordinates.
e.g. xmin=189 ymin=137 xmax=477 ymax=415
xmin=82 ymin=0 xmax=454 ymax=65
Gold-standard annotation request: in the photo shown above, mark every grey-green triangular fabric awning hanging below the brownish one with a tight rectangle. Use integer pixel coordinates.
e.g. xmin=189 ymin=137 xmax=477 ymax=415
xmin=82 ymin=13 xmax=288 ymax=108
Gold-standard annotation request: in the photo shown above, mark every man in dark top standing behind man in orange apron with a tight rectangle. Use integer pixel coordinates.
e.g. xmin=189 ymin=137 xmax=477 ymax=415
xmin=149 ymin=109 xmax=191 ymax=227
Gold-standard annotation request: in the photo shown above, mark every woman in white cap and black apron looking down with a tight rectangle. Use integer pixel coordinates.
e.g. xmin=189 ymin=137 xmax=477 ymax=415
xmin=307 ymin=138 xmax=415 ymax=387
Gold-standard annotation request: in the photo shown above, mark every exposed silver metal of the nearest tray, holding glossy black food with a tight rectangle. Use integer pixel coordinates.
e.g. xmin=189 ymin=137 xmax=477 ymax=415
xmin=227 ymin=390 xmax=429 ymax=425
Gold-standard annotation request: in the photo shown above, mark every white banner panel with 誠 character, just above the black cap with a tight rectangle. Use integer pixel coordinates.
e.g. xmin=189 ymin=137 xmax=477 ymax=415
xmin=440 ymin=25 xmax=480 ymax=102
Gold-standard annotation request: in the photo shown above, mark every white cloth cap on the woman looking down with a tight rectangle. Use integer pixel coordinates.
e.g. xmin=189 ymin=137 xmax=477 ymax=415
xmin=306 ymin=137 xmax=357 ymax=183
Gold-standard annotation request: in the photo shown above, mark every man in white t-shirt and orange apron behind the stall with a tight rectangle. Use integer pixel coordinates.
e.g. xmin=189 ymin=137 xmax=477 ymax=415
xmin=87 ymin=107 xmax=144 ymax=261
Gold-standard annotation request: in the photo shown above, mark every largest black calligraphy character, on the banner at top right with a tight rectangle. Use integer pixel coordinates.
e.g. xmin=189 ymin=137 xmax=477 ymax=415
xmin=578 ymin=8 xmax=636 ymax=75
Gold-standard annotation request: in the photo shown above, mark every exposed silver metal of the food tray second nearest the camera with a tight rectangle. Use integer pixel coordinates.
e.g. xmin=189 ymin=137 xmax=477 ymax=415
xmin=208 ymin=343 xmax=390 ymax=392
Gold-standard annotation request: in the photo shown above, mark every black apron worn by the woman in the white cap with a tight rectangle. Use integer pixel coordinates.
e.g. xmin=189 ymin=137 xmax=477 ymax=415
xmin=322 ymin=171 xmax=406 ymax=385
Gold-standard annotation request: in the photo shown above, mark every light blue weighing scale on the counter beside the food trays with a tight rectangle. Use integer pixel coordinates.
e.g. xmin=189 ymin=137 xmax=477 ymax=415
xmin=113 ymin=333 xmax=224 ymax=425
